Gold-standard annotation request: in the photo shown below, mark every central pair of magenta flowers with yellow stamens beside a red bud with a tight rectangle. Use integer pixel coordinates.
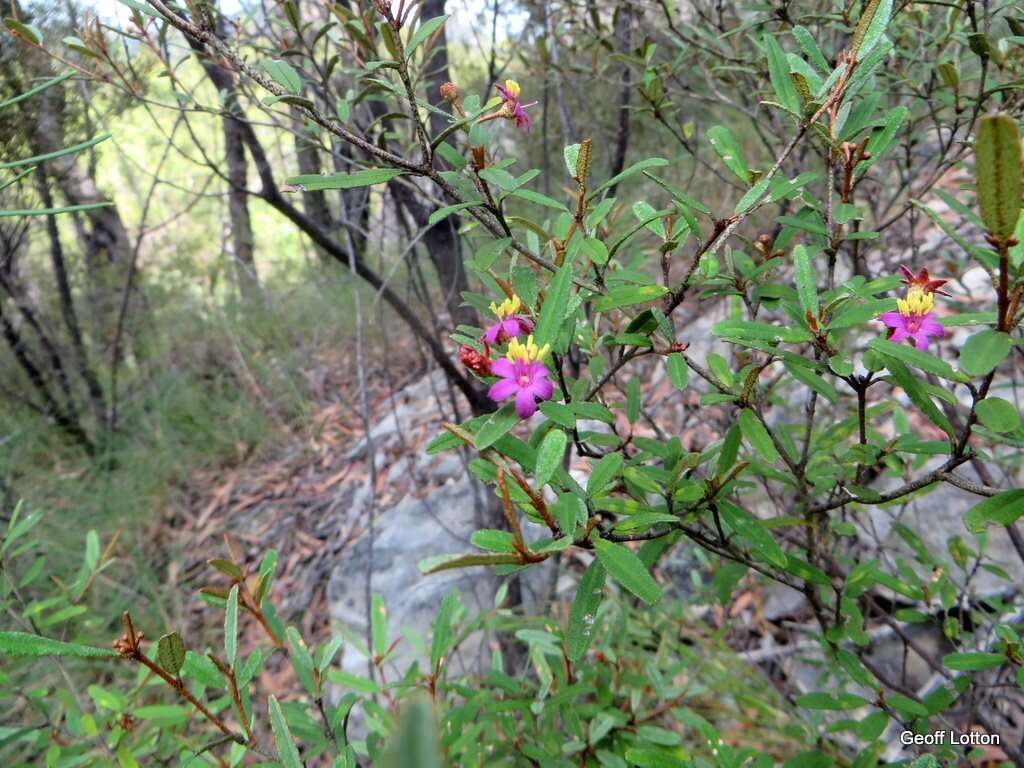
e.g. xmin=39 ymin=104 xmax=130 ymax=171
xmin=459 ymin=296 xmax=554 ymax=419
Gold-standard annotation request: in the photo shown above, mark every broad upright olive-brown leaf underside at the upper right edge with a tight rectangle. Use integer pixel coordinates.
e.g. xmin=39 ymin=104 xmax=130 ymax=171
xmin=974 ymin=115 xmax=1021 ymax=240
